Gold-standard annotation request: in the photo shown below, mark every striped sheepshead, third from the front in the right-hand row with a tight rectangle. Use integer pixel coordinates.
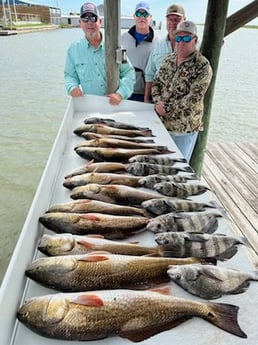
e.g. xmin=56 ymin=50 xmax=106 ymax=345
xmin=147 ymin=212 xmax=220 ymax=234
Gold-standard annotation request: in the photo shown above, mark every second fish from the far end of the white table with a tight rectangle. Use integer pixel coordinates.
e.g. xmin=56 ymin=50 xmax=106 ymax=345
xmin=73 ymin=123 xmax=154 ymax=137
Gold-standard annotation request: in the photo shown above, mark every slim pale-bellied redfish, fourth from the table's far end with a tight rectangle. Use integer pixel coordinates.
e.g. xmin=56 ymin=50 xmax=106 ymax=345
xmin=75 ymin=137 xmax=168 ymax=151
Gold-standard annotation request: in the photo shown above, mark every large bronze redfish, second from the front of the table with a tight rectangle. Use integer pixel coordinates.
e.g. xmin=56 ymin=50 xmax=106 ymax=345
xmin=26 ymin=253 xmax=204 ymax=291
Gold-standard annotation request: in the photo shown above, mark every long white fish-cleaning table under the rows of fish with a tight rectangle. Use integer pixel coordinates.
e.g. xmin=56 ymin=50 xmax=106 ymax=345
xmin=0 ymin=95 xmax=258 ymax=345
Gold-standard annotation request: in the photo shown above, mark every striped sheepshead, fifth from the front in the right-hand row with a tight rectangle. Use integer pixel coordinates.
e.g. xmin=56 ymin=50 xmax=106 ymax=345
xmin=154 ymin=181 xmax=210 ymax=198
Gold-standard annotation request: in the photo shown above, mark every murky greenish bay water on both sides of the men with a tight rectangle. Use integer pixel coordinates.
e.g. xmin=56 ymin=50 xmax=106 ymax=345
xmin=0 ymin=29 xmax=258 ymax=281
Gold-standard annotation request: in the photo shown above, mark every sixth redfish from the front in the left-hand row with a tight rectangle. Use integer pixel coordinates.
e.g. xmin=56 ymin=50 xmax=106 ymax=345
xmin=70 ymin=183 xmax=164 ymax=206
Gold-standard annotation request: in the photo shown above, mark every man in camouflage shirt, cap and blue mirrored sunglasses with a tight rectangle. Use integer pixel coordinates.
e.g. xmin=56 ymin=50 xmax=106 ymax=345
xmin=151 ymin=20 xmax=212 ymax=161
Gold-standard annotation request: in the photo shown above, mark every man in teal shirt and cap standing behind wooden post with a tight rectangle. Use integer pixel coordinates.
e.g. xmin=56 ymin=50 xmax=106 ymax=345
xmin=64 ymin=2 xmax=135 ymax=105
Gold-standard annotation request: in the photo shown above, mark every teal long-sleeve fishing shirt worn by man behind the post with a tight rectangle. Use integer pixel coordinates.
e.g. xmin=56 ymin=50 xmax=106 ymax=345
xmin=64 ymin=37 xmax=135 ymax=99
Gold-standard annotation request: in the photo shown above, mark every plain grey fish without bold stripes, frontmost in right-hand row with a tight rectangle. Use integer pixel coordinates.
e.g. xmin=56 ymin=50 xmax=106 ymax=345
xmin=168 ymin=264 xmax=258 ymax=299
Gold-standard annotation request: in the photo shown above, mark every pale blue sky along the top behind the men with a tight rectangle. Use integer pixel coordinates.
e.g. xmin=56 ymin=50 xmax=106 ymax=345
xmin=31 ymin=0 xmax=258 ymax=25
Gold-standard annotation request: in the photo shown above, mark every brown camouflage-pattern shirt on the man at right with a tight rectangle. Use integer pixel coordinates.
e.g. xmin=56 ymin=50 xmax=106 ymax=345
xmin=151 ymin=50 xmax=212 ymax=133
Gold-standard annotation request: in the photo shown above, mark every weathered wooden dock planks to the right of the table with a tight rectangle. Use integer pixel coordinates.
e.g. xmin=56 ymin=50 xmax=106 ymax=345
xmin=202 ymin=143 xmax=258 ymax=267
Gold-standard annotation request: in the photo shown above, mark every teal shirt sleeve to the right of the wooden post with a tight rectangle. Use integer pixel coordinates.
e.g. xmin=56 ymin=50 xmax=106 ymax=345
xmin=116 ymin=59 xmax=135 ymax=99
